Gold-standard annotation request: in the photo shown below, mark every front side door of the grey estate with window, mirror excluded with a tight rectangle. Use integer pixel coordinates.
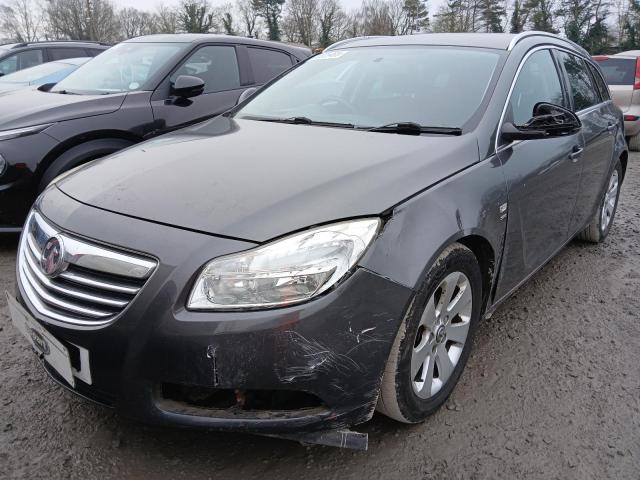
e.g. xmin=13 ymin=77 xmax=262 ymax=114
xmin=496 ymin=49 xmax=584 ymax=299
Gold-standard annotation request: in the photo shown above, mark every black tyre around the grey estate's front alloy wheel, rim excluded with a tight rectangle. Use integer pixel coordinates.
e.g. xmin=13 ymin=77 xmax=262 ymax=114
xmin=377 ymin=243 xmax=482 ymax=423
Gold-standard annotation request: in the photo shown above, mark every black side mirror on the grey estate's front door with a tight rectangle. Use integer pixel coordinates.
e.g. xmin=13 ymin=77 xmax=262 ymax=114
xmin=502 ymin=102 xmax=582 ymax=142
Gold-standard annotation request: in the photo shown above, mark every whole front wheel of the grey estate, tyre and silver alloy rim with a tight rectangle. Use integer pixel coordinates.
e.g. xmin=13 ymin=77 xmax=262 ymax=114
xmin=377 ymin=243 xmax=482 ymax=423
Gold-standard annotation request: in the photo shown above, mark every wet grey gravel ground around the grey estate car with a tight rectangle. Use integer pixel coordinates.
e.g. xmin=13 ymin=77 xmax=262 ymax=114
xmin=0 ymin=155 xmax=640 ymax=480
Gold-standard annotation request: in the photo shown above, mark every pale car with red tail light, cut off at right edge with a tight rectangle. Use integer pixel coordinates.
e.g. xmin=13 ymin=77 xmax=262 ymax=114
xmin=593 ymin=50 xmax=640 ymax=152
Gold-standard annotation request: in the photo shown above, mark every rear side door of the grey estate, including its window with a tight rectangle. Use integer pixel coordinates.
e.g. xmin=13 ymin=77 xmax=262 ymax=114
xmin=556 ymin=51 xmax=619 ymax=236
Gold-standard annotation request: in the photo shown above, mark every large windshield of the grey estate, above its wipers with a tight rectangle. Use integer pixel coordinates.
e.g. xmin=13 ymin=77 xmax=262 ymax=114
xmin=236 ymin=46 xmax=500 ymax=128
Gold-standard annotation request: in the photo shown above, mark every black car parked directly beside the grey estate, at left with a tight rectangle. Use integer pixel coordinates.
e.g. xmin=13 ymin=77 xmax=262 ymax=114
xmin=0 ymin=34 xmax=311 ymax=232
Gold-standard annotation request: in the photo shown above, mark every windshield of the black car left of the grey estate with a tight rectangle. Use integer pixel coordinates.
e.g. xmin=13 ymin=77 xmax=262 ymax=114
xmin=53 ymin=42 xmax=185 ymax=95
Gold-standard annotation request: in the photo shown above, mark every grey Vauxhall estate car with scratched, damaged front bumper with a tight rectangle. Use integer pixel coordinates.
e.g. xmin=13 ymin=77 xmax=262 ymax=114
xmin=9 ymin=32 xmax=628 ymax=448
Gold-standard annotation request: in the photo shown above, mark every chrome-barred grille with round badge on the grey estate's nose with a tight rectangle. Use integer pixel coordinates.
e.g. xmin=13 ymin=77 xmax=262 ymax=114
xmin=18 ymin=212 xmax=156 ymax=326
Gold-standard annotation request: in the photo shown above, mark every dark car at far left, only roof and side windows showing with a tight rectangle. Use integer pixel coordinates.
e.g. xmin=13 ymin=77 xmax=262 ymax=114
xmin=0 ymin=41 xmax=110 ymax=77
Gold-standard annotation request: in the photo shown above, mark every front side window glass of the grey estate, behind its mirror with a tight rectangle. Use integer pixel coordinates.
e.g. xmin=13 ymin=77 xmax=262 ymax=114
xmin=509 ymin=50 xmax=565 ymax=125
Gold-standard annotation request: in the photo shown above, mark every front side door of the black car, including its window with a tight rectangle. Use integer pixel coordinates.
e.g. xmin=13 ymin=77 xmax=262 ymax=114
xmin=151 ymin=45 xmax=247 ymax=134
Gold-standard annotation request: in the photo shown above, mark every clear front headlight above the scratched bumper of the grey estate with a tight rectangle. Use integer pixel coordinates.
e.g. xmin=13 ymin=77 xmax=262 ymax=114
xmin=187 ymin=218 xmax=381 ymax=310
